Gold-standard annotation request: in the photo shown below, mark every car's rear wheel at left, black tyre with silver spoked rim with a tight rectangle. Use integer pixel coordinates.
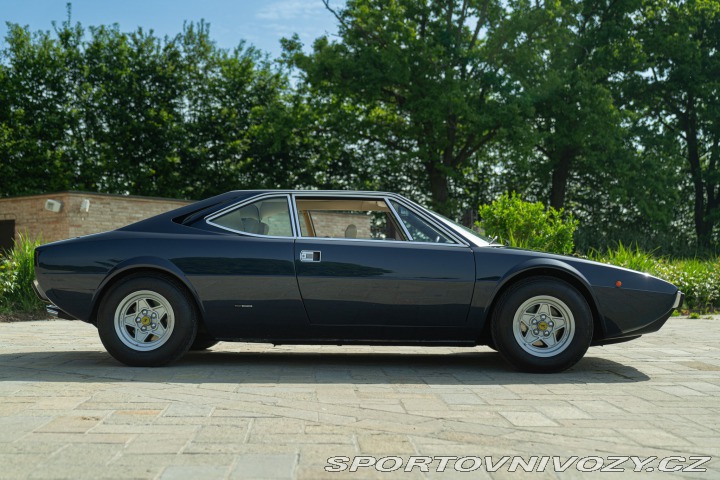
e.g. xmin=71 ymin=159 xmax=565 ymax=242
xmin=97 ymin=274 xmax=198 ymax=367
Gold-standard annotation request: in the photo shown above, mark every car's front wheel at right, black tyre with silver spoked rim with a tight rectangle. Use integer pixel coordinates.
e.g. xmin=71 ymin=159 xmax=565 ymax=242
xmin=491 ymin=277 xmax=593 ymax=373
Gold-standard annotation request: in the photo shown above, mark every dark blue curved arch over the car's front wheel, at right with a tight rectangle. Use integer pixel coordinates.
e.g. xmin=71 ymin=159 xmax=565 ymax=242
xmin=479 ymin=259 xmax=605 ymax=344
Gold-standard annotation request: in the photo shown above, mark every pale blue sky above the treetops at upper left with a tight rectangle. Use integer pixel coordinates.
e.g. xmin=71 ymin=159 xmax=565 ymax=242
xmin=0 ymin=0 xmax=344 ymax=57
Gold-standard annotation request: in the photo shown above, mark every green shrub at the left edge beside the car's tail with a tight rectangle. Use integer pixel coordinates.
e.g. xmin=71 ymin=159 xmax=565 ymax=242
xmin=0 ymin=235 xmax=43 ymax=313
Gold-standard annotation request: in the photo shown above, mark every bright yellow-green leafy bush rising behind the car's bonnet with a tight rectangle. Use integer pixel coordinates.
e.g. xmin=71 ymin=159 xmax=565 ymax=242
xmin=478 ymin=192 xmax=578 ymax=255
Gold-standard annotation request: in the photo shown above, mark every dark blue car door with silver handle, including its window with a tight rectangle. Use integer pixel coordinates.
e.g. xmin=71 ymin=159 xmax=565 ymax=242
xmin=294 ymin=195 xmax=475 ymax=327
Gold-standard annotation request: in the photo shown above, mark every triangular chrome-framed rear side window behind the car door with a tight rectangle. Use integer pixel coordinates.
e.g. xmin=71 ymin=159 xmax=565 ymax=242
xmin=208 ymin=197 xmax=293 ymax=237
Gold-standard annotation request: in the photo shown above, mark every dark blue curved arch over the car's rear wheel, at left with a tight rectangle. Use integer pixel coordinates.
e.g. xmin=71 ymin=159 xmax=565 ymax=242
xmin=90 ymin=257 xmax=205 ymax=324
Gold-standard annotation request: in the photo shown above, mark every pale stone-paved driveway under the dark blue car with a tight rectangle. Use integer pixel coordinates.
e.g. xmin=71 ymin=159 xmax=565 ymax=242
xmin=0 ymin=317 xmax=720 ymax=480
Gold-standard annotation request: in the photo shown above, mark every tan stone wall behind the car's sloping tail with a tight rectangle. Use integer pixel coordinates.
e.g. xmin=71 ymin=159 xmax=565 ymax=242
xmin=0 ymin=192 xmax=190 ymax=242
